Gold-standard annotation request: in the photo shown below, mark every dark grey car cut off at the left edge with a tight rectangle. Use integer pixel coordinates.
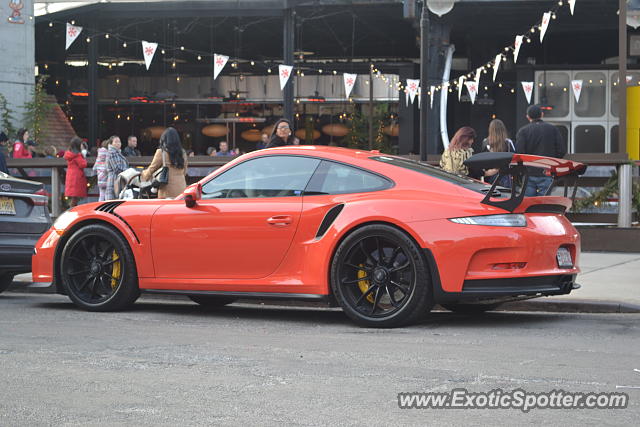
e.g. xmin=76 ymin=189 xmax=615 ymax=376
xmin=0 ymin=172 xmax=51 ymax=292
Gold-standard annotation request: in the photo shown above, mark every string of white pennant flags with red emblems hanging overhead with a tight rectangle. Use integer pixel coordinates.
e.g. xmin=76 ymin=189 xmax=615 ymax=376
xmin=61 ymin=0 xmax=583 ymax=104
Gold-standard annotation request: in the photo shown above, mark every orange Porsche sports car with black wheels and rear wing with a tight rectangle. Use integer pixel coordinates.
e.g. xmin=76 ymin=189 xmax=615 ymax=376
xmin=33 ymin=146 xmax=581 ymax=327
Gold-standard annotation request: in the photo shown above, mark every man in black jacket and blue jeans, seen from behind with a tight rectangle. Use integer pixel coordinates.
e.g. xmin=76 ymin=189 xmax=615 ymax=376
xmin=516 ymin=105 xmax=567 ymax=197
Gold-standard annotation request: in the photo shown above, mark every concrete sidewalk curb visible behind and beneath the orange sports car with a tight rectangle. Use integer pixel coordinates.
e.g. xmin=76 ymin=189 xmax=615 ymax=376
xmin=6 ymin=281 xmax=640 ymax=314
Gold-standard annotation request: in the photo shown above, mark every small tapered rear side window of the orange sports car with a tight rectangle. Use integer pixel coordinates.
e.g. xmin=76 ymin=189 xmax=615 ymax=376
xmin=306 ymin=161 xmax=391 ymax=195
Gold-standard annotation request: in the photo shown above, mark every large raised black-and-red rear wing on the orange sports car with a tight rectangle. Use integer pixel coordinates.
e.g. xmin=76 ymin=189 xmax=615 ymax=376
xmin=464 ymin=152 xmax=587 ymax=212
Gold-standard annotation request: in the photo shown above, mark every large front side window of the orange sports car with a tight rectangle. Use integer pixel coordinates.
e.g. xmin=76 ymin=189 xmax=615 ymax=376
xmin=202 ymin=156 xmax=320 ymax=199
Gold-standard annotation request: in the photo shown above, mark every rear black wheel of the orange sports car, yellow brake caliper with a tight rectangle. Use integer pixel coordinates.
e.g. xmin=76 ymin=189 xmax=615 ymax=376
xmin=331 ymin=224 xmax=433 ymax=328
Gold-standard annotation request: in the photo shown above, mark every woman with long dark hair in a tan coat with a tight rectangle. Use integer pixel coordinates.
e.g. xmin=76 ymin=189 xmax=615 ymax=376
xmin=140 ymin=127 xmax=188 ymax=199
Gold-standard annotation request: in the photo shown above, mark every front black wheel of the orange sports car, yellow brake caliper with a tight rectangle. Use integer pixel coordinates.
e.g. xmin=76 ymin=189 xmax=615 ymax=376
xmin=60 ymin=224 xmax=140 ymax=311
